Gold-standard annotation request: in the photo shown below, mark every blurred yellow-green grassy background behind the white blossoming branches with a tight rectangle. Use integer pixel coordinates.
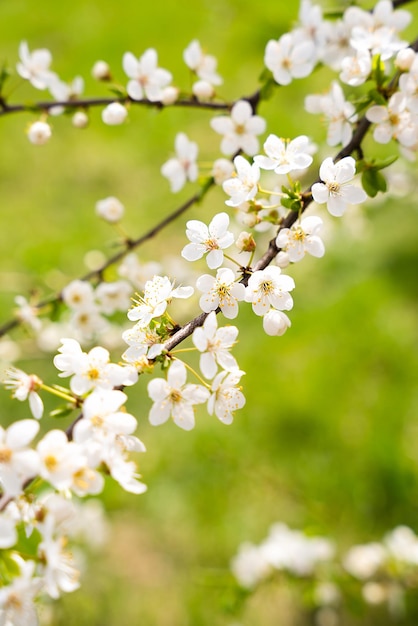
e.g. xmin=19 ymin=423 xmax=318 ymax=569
xmin=0 ymin=0 xmax=418 ymax=626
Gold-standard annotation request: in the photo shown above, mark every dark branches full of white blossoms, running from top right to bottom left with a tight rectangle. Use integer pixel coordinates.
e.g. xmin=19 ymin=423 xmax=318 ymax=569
xmin=0 ymin=0 xmax=418 ymax=624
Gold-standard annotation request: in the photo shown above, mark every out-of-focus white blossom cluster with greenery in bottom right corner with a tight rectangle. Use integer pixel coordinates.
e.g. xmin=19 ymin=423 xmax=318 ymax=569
xmin=231 ymin=523 xmax=418 ymax=624
